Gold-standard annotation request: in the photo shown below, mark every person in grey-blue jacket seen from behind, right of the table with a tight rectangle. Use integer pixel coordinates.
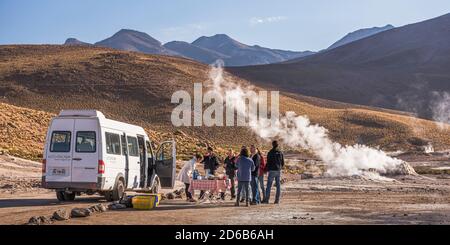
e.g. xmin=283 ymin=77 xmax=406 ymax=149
xmin=235 ymin=148 xmax=255 ymax=206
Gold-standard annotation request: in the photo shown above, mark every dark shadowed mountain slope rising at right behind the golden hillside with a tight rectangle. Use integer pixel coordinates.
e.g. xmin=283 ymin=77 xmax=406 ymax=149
xmin=228 ymin=14 xmax=450 ymax=118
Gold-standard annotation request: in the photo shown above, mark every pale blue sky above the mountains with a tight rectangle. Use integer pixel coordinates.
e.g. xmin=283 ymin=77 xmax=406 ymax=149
xmin=0 ymin=0 xmax=450 ymax=50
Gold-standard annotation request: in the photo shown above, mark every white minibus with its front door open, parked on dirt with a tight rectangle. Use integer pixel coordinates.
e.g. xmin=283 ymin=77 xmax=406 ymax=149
xmin=42 ymin=110 xmax=176 ymax=201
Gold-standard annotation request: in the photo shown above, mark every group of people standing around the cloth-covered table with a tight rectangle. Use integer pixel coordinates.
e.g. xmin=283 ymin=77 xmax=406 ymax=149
xmin=178 ymin=141 xmax=284 ymax=206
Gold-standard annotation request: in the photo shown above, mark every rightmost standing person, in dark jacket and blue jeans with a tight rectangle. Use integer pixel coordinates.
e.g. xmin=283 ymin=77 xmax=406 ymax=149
xmin=263 ymin=141 xmax=284 ymax=204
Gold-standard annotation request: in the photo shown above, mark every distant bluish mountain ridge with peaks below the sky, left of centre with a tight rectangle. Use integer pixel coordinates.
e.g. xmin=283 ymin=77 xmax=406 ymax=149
xmin=65 ymin=29 xmax=314 ymax=66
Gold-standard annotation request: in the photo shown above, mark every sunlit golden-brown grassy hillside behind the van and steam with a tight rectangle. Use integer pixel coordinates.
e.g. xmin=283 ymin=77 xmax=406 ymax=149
xmin=0 ymin=45 xmax=450 ymax=159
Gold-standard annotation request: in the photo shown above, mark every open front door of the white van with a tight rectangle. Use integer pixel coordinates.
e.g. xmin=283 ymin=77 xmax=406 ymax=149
xmin=156 ymin=140 xmax=177 ymax=188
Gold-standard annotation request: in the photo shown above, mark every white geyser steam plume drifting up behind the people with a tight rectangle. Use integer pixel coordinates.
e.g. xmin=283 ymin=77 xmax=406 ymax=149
xmin=210 ymin=61 xmax=403 ymax=176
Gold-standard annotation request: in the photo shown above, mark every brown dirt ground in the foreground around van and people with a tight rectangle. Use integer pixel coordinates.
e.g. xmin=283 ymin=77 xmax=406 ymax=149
xmin=0 ymin=177 xmax=450 ymax=225
